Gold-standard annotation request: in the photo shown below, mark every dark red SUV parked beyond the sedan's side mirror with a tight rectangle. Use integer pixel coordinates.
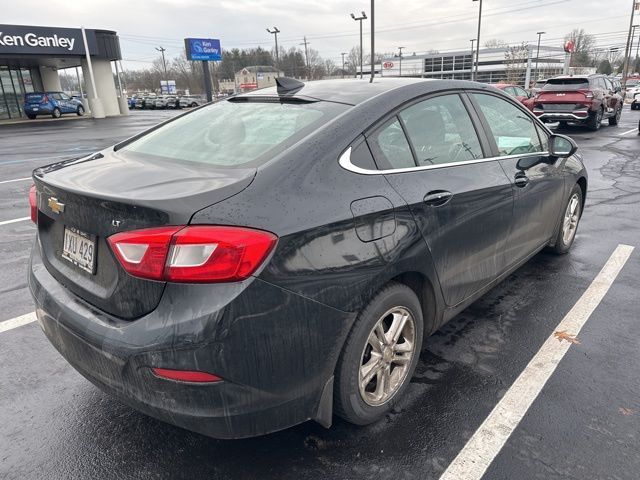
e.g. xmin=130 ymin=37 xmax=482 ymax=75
xmin=533 ymin=75 xmax=624 ymax=130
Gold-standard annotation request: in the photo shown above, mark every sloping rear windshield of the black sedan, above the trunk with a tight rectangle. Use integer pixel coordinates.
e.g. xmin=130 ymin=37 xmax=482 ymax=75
xmin=120 ymin=101 xmax=348 ymax=167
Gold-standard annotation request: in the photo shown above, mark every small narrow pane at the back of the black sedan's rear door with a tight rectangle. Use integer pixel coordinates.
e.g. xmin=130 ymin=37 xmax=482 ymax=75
xmin=369 ymin=117 xmax=416 ymax=170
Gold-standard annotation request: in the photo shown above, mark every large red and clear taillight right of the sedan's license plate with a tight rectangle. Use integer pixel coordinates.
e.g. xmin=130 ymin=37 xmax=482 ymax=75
xmin=108 ymin=225 xmax=277 ymax=283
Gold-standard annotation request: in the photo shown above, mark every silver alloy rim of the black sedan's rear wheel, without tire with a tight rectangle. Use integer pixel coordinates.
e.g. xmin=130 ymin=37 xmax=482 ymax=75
xmin=358 ymin=307 xmax=416 ymax=406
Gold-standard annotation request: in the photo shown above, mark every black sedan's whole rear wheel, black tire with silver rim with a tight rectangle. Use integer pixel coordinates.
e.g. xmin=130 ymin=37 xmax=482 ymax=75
xmin=334 ymin=283 xmax=424 ymax=425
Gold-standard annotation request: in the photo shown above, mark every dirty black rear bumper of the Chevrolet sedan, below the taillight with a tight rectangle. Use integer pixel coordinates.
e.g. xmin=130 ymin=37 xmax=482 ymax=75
xmin=29 ymin=242 xmax=353 ymax=438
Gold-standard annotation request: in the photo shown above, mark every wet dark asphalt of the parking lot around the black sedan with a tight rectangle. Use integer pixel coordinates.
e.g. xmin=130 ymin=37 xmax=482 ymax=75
xmin=0 ymin=108 xmax=640 ymax=480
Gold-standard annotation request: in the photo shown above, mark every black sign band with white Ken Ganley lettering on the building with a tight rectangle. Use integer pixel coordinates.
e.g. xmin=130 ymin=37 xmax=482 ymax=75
xmin=0 ymin=25 xmax=97 ymax=55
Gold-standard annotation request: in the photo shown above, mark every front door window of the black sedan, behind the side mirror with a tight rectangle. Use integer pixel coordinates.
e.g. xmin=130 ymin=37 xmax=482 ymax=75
xmin=473 ymin=93 xmax=543 ymax=157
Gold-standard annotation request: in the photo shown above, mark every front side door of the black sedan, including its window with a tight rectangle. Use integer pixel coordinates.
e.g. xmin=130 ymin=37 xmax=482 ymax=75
xmin=470 ymin=92 xmax=564 ymax=265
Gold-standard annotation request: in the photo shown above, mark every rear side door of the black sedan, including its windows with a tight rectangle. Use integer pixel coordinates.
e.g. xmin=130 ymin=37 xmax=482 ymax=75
xmin=368 ymin=93 xmax=513 ymax=306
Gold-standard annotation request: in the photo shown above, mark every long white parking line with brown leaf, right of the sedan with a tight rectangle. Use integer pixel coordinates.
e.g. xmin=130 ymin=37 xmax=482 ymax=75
xmin=440 ymin=245 xmax=633 ymax=480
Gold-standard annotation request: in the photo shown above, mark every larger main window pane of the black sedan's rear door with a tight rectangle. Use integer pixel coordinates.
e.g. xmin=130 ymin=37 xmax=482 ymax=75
xmin=400 ymin=95 xmax=482 ymax=166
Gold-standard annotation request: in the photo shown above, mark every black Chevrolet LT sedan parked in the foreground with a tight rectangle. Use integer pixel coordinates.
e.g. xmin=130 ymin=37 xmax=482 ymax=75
xmin=29 ymin=78 xmax=587 ymax=438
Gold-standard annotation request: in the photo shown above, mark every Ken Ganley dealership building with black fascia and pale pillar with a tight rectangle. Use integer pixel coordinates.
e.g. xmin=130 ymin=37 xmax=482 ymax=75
xmin=0 ymin=25 xmax=128 ymax=120
